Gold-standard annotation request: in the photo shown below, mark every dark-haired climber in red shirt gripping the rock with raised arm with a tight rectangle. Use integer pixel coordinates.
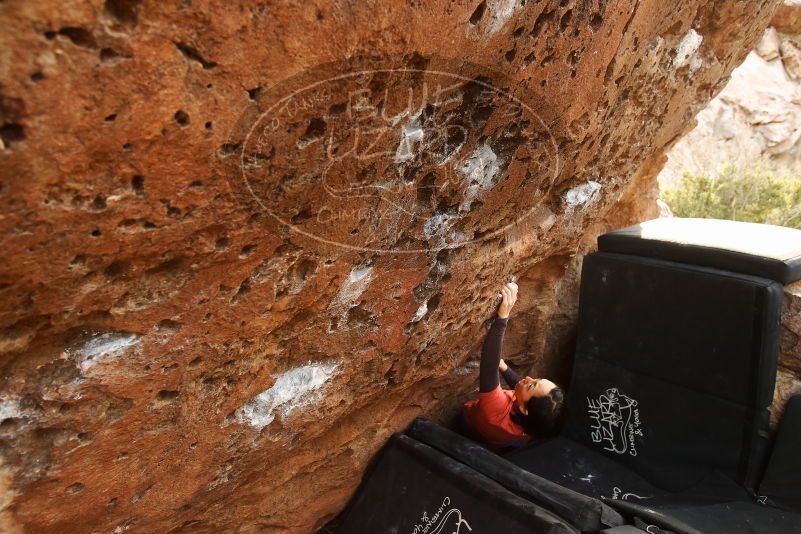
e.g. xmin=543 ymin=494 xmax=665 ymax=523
xmin=462 ymin=282 xmax=566 ymax=450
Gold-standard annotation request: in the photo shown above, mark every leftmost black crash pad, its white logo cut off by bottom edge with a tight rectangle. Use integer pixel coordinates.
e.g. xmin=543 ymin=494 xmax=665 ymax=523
xmin=337 ymin=434 xmax=579 ymax=534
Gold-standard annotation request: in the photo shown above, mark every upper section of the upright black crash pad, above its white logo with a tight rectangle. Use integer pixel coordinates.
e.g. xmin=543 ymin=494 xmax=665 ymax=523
xmin=571 ymin=253 xmax=784 ymax=409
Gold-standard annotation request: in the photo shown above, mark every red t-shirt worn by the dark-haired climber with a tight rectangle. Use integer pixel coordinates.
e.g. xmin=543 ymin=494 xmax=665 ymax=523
xmin=464 ymin=385 xmax=529 ymax=445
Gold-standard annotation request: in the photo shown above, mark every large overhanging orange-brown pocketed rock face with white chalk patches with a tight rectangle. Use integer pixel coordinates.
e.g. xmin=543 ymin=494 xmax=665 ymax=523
xmin=0 ymin=0 xmax=777 ymax=532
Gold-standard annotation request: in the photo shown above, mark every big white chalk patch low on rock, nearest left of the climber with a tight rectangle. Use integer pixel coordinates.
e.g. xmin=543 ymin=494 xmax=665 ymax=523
xmin=236 ymin=362 xmax=339 ymax=430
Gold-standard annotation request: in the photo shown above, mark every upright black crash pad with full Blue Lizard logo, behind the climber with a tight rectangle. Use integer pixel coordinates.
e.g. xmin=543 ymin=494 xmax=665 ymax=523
xmin=565 ymin=253 xmax=782 ymax=492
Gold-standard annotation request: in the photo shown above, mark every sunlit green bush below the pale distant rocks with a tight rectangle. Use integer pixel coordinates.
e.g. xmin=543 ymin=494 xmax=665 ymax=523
xmin=661 ymin=166 xmax=801 ymax=229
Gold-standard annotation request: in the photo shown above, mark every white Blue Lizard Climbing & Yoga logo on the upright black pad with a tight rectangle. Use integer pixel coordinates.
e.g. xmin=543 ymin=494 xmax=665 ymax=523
xmin=587 ymin=388 xmax=642 ymax=456
